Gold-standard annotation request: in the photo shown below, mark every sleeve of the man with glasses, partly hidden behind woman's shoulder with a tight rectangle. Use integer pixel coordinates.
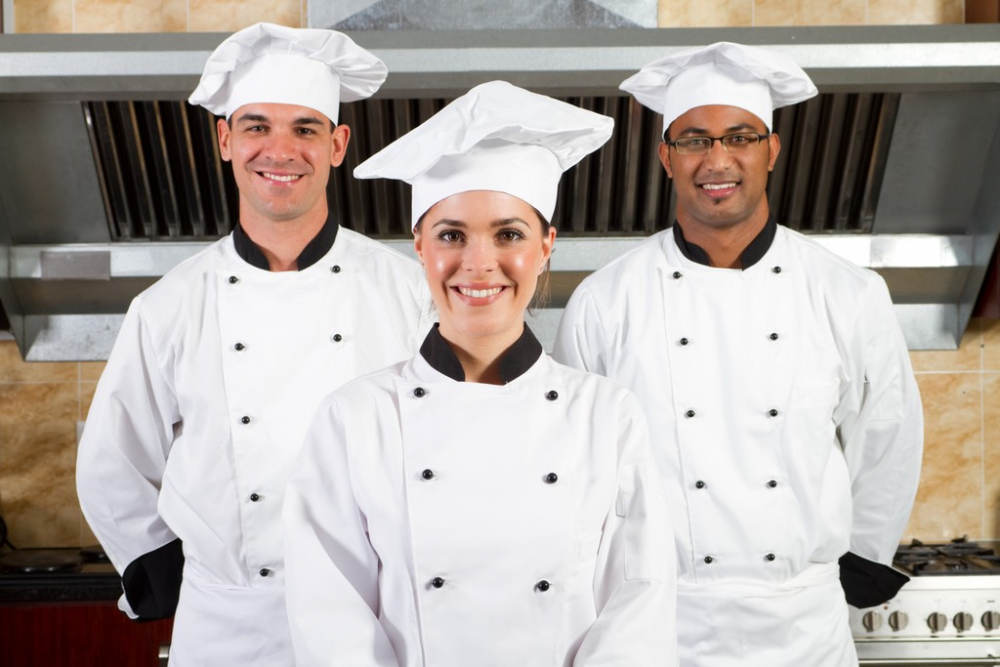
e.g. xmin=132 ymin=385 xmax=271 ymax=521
xmin=552 ymin=283 xmax=611 ymax=376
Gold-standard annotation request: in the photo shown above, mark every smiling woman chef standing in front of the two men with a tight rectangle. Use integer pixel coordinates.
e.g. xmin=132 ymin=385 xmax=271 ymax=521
xmin=285 ymin=81 xmax=676 ymax=667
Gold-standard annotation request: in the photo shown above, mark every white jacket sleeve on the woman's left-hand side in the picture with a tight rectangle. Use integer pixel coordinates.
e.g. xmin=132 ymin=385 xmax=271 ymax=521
xmin=283 ymin=399 xmax=398 ymax=667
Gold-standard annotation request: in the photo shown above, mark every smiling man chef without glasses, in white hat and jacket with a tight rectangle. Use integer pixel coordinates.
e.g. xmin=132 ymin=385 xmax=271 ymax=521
xmin=77 ymin=24 xmax=430 ymax=667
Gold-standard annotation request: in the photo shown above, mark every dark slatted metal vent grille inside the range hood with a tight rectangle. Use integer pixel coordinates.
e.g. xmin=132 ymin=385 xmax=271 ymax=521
xmin=84 ymin=93 xmax=899 ymax=241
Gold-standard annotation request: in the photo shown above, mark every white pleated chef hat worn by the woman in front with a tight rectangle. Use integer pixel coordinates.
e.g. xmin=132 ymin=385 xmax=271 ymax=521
xmin=354 ymin=81 xmax=614 ymax=227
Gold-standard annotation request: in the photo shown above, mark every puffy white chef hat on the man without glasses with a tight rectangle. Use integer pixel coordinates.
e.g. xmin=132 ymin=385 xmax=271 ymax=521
xmin=188 ymin=23 xmax=388 ymax=123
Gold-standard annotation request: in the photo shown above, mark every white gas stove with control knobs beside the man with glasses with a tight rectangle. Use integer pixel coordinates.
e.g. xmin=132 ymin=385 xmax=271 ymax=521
xmin=850 ymin=538 xmax=1000 ymax=667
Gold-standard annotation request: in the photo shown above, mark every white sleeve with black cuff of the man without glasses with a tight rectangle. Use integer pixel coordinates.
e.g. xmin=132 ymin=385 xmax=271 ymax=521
xmin=76 ymin=297 xmax=183 ymax=618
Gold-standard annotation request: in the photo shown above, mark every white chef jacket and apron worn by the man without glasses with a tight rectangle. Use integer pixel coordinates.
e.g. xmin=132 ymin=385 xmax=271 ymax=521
xmin=77 ymin=221 xmax=433 ymax=667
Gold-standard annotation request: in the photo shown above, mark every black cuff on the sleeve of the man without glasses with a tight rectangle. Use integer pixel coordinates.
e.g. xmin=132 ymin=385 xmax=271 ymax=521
xmin=122 ymin=538 xmax=184 ymax=620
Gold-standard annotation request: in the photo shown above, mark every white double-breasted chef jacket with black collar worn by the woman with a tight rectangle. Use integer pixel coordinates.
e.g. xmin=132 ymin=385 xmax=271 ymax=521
xmin=285 ymin=327 xmax=676 ymax=667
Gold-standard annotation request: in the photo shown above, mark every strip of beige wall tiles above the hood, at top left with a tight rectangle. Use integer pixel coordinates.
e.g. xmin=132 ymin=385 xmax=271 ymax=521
xmin=14 ymin=0 xmax=306 ymax=33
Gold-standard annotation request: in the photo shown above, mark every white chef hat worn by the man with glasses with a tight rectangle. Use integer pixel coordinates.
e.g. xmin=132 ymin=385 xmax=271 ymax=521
xmin=621 ymin=42 xmax=817 ymax=135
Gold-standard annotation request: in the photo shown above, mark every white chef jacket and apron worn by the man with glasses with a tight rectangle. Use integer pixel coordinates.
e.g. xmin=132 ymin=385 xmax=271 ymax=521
xmin=554 ymin=221 xmax=923 ymax=667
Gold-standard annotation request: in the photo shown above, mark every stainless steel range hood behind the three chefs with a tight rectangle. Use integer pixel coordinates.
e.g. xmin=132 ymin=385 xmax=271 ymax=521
xmin=0 ymin=26 xmax=1000 ymax=361
